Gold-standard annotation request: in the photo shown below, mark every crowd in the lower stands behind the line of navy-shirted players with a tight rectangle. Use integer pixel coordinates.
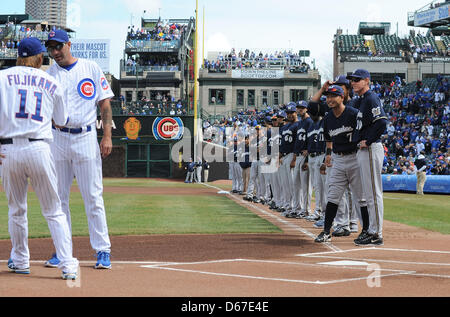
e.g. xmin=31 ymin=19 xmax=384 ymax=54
xmin=203 ymin=75 xmax=450 ymax=175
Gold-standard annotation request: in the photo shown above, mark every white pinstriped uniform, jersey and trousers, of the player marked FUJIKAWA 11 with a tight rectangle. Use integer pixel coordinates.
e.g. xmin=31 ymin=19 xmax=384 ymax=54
xmin=0 ymin=67 xmax=78 ymax=273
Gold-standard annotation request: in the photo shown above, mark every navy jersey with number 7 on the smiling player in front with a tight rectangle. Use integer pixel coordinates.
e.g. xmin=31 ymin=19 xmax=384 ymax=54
xmin=323 ymin=106 xmax=358 ymax=153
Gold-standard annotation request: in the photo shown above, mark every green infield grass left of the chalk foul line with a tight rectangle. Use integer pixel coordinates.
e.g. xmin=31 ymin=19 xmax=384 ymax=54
xmin=0 ymin=180 xmax=281 ymax=239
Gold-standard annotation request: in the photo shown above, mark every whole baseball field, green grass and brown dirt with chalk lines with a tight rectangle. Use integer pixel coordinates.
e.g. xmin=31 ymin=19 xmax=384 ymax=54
xmin=0 ymin=178 xmax=450 ymax=298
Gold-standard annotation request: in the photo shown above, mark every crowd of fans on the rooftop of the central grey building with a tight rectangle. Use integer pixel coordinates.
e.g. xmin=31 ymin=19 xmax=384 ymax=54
xmin=203 ymin=48 xmax=310 ymax=72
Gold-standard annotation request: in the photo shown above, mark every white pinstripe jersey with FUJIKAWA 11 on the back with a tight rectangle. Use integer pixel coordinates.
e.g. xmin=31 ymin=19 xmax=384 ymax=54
xmin=0 ymin=66 xmax=68 ymax=141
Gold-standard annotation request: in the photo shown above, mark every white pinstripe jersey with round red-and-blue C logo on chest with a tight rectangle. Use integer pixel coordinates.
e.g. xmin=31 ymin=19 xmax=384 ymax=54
xmin=47 ymin=58 xmax=114 ymax=128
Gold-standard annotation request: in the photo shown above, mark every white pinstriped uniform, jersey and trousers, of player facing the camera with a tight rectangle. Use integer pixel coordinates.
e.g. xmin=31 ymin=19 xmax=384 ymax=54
xmin=48 ymin=58 xmax=114 ymax=252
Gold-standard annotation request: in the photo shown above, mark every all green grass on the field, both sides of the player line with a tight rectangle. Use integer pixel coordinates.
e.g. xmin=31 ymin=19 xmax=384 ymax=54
xmin=0 ymin=178 xmax=450 ymax=239
